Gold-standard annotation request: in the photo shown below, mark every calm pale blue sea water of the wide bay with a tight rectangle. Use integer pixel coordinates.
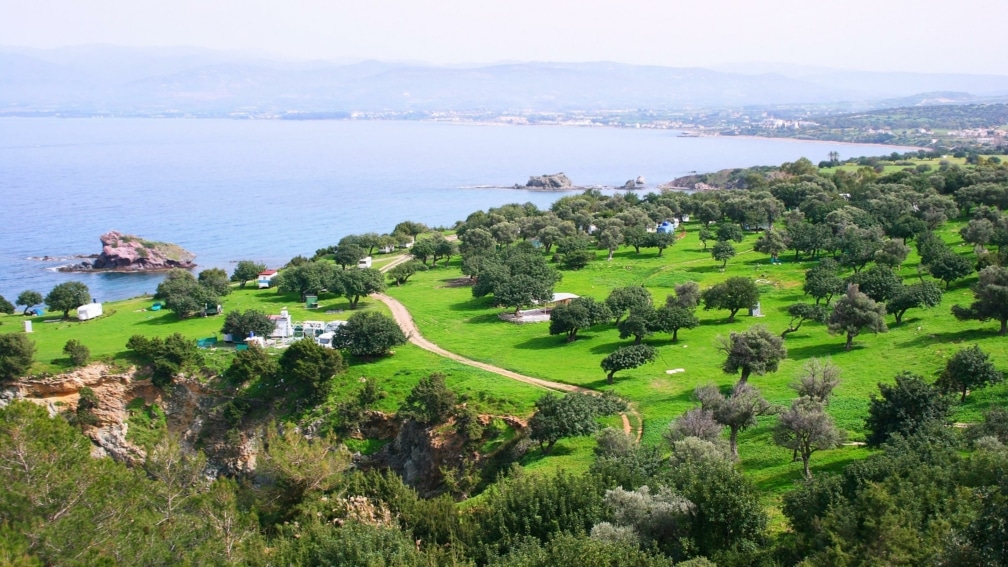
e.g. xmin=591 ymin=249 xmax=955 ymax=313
xmin=0 ymin=118 xmax=892 ymax=301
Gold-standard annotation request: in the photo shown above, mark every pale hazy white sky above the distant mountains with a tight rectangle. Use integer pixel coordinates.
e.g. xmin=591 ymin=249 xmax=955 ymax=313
xmin=0 ymin=0 xmax=1008 ymax=75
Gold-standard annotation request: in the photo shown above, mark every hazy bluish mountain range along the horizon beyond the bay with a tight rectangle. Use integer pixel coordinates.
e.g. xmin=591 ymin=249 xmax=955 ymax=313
xmin=0 ymin=45 xmax=1008 ymax=116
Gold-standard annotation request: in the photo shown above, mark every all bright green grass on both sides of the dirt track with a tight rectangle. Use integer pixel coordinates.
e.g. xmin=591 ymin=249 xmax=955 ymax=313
xmin=7 ymin=214 xmax=1008 ymax=505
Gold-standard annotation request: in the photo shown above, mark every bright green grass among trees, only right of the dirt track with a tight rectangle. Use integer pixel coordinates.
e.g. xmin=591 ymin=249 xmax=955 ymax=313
xmin=389 ymin=224 xmax=1008 ymax=493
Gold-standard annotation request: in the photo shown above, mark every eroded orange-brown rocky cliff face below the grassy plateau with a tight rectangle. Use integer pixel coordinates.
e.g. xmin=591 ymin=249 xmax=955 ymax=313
xmin=0 ymin=364 xmax=527 ymax=490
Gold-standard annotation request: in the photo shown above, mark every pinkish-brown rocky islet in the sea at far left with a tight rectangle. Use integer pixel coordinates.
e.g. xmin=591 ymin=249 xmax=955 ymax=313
xmin=60 ymin=231 xmax=196 ymax=271
